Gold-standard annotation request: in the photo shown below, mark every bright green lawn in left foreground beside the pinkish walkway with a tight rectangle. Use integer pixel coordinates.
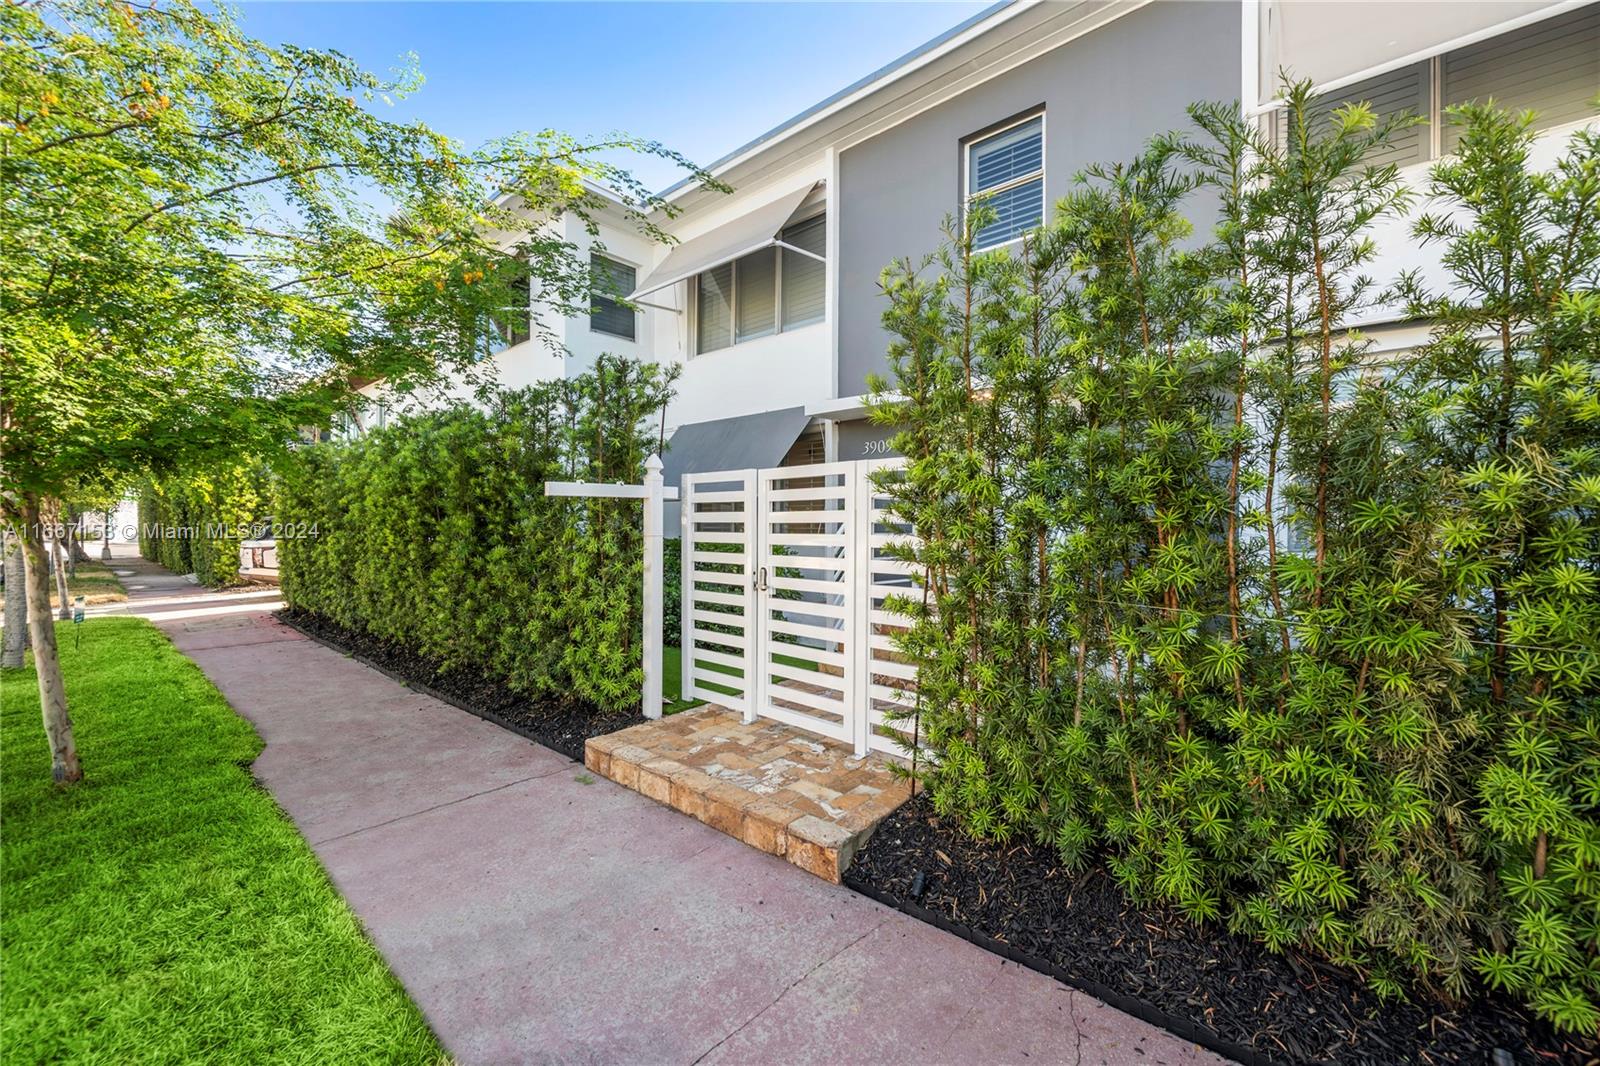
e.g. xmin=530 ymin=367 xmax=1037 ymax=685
xmin=0 ymin=618 xmax=445 ymax=1063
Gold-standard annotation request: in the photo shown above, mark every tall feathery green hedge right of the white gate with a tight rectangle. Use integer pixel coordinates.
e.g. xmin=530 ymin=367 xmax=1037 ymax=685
xmin=874 ymin=99 xmax=1600 ymax=1032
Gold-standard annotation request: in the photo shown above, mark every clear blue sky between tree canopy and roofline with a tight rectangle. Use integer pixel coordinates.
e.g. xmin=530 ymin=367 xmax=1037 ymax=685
xmin=240 ymin=2 xmax=987 ymax=189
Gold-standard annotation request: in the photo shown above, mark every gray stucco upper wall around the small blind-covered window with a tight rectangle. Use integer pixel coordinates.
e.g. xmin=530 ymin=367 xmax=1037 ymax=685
xmin=838 ymin=0 xmax=1240 ymax=392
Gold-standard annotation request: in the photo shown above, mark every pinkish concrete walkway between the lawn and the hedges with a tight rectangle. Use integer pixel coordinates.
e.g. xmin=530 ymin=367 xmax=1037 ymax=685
xmin=115 ymin=557 xmax=1222 ymax=1066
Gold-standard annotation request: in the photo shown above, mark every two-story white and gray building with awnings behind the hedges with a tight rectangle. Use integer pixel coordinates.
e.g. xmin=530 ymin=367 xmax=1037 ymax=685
xmin=356 ymin=0 xmax=1600 ymax=482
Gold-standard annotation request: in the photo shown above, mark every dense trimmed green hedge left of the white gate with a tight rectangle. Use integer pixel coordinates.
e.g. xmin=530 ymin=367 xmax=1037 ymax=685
xmin=277 ymin=357 xmax=672 ymax=709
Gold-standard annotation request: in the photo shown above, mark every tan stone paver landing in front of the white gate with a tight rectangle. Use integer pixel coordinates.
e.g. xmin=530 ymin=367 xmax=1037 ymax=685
xmin=584 ymin=706 xmax=910 ymax=885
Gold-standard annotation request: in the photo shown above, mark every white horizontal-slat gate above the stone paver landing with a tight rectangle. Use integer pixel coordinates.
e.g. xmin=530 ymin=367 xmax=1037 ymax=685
xmin=680 ymin=459 xmax=915 ymax=754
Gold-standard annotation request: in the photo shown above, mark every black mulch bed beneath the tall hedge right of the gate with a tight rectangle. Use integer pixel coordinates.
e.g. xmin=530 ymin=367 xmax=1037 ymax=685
xmin=845 ymin=795 xmax=1600 ymax=1066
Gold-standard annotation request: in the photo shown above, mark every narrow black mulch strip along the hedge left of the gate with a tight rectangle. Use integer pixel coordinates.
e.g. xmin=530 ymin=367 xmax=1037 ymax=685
xmin=277 ymin=608 xmax=645 ymax=762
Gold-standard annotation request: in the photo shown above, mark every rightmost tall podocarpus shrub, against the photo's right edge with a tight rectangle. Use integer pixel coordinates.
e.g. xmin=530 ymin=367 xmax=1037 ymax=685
xmin=1406 ymin=107 xmax=1600 ymax=1029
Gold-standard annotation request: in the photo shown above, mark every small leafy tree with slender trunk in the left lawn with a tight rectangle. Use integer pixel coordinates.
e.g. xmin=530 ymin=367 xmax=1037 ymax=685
xmin=0 ymin=0 xmax=713 ymax=781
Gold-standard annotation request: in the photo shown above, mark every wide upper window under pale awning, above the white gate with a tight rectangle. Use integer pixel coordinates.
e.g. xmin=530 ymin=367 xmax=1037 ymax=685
xmin=693 ymin=214 xmax=827 ymax=354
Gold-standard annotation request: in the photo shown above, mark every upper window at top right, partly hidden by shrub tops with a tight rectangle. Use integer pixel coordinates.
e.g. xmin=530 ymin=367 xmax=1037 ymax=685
xmin=1275 ymin=5 xmax=1600 ymax=166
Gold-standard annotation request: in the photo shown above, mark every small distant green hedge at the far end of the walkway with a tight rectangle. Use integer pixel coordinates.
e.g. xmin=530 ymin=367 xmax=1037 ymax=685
xmin=139 ymin=463 xmax=269 ymax=589
